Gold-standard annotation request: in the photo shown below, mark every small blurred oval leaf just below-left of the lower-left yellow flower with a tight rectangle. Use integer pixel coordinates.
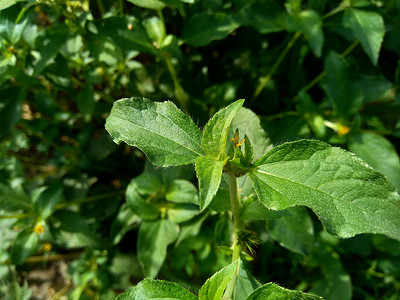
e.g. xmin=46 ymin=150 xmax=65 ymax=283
xmin=11 ymin=228 xmax=39 ymax=265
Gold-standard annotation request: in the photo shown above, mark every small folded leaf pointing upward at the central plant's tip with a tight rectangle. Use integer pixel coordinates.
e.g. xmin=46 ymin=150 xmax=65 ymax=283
xmin=201 ymin=100 xmax=244 ymax=160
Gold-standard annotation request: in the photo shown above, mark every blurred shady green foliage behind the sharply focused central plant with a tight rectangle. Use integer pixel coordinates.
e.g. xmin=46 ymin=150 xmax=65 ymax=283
xmin=0 ymin=0 xmax=400 ymax=299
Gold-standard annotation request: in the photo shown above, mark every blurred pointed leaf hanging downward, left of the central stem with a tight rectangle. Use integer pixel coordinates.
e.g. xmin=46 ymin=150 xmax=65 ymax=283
xmin=137 ymin=219 xmax=179 ymax=278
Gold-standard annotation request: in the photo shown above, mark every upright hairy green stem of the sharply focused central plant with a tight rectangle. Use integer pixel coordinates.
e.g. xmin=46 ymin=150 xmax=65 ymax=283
xmin=224 ymin=174 xmax=243 ymax=299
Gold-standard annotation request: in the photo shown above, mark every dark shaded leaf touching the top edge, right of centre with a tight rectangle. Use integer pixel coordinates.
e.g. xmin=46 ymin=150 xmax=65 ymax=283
xmin=235 ymin=0 xmax=286 ymax=34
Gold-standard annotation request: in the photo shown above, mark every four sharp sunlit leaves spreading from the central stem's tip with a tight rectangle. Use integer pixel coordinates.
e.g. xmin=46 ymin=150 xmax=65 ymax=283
xmin=106 ymin=98 xmax=400 ymax=240
